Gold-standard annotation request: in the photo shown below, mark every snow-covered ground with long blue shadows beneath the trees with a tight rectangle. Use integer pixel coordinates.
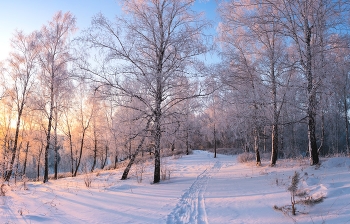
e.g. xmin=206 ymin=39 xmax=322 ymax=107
xmin=0 ymin=151 xmax=350 ymax=224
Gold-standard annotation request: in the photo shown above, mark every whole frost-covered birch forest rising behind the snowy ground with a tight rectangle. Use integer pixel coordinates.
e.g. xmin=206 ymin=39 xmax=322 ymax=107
xmin=0 ymin=0 xmax=350 ymax=186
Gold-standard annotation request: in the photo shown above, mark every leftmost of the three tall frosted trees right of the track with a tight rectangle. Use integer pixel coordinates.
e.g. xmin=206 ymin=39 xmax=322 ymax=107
xmin=219 ymin=13 xmax=264 ymax=165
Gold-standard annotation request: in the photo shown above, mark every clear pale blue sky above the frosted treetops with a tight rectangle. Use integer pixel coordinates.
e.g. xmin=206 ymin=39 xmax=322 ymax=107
xmin=0 ymin=0 xmax=217 ymax=61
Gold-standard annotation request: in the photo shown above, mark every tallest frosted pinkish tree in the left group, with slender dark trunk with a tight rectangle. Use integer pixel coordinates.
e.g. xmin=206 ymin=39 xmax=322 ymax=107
xmin=39 ymin=11 xmax=77 ymax=183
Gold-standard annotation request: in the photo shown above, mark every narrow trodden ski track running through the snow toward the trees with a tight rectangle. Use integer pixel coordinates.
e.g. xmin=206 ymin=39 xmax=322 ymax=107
xmin=167 ymin=161 xmax=222 ymax=224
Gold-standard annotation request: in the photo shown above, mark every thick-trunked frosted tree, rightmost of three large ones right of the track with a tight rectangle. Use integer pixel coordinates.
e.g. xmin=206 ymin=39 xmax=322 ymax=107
xmin=266 ymin=0 xmax=349 ymax=165
